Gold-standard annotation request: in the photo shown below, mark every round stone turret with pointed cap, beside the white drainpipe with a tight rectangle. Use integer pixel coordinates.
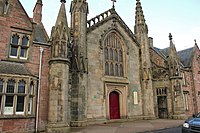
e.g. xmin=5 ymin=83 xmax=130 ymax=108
xmin=47 ymin=0 xmax=70 ymax=133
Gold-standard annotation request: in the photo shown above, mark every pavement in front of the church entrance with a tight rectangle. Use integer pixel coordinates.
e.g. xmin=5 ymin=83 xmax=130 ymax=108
xmin=70 ymin=119 xmax=184 ymax=133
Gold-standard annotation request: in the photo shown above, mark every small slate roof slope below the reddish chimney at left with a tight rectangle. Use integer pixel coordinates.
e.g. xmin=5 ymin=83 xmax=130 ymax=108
xmin=33 ymin=23 xmax=49 ymax=43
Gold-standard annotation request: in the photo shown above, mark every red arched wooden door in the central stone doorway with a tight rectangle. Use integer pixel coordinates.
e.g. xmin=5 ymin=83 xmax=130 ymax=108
xmin=109 ymin=91 xmax=120 ymax=119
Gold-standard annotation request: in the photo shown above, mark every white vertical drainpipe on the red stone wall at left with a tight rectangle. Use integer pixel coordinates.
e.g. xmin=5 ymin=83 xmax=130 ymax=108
xmin=35 ymin=47 xmax=44 ymax=132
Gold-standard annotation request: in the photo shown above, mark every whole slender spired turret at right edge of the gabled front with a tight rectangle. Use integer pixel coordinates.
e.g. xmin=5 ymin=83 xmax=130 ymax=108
xmin=134 ymin=0 xmax=155 ymax=118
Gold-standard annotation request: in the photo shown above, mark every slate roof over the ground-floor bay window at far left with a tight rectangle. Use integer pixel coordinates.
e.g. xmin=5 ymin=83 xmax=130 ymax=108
xmin=0 ymin=61 xmax=31 ymax=75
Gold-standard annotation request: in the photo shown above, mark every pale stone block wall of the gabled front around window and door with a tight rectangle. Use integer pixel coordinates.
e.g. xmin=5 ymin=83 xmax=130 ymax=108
xmin=87 ymin=20 xmax=142 ymax=120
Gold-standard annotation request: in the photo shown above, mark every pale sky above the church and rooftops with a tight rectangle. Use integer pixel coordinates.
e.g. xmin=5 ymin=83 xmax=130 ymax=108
xmin=20 ymin=0 xmax=200 ymax=51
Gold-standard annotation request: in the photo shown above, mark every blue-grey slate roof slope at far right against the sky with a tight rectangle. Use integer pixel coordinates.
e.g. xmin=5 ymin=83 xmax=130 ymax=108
xmin=178 ymin=47 xmax=193 ymax=67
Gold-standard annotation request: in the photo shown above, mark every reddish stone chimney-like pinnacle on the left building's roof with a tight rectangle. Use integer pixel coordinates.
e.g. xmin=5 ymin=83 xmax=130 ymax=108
xmin=33 ymin=0 xmax=43 ymax=23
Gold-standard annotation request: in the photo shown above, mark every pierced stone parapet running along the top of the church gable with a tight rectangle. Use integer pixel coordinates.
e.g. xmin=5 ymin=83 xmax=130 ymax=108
xmin=87 ymin=8 xmax=136 ymax=42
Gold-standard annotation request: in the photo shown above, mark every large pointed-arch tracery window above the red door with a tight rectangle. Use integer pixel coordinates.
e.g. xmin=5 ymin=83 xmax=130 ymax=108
xmin=103 ymin=32 xmax=124 ymax=77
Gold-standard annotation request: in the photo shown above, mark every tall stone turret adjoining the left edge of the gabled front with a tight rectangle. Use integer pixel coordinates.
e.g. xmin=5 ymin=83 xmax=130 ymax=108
xmin=70 ymin=0 xmax=88 ymax=126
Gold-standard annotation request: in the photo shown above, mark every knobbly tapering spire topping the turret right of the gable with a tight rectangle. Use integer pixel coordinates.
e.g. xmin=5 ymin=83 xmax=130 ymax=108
xmin=135 ymin=0 xmax=145 ymax=24
